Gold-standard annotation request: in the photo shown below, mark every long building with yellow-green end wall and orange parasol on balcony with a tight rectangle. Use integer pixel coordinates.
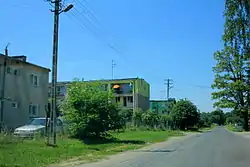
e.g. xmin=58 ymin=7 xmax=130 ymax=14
xmin=49 ymin=78 xmax=150 ymax=111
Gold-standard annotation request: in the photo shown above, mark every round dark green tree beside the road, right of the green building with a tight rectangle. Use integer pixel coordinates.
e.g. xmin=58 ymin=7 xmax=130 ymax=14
xmin=170 ymin=100 xmax=199 ymax=130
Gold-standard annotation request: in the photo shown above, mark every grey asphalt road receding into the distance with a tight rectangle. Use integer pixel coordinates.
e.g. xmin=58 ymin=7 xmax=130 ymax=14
xmin=78 ymin=127 xmax=250 ymax=167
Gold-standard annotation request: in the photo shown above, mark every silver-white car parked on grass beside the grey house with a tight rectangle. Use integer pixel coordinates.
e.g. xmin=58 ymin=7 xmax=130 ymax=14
xmin=14 ymin=118 xmax=63 ymax=137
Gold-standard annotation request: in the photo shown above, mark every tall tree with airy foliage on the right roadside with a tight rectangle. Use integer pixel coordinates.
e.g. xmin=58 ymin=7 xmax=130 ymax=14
xmin=212 ymin=0 xmax=250 ymax=131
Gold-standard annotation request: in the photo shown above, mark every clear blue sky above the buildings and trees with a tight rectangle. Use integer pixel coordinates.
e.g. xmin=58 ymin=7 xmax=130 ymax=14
xmin=0 ymin=0 xmax=224 ymax=112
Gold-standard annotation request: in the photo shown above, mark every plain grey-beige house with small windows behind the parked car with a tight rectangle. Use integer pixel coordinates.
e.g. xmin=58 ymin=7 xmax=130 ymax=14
xmin=0 ymin=54 xmax=50 ymax=128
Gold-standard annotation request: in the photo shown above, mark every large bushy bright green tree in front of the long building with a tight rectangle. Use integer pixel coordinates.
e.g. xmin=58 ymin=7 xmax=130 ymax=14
xmin=61 ymin=81 xmax=124 ymax=138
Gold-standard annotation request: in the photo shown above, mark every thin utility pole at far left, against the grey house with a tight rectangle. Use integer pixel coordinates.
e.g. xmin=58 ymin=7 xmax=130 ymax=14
xmin=0 ymin=43 xmax=9 ymax=132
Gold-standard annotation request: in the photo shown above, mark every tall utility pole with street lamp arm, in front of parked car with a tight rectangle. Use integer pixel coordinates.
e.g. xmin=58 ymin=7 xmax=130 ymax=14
xmin=47 ymin=0 xmax=73 ymax=145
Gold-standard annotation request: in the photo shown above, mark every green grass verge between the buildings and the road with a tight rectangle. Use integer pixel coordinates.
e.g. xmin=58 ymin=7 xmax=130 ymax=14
xmin=0 ymin=131 xmax=180 ymax=167
